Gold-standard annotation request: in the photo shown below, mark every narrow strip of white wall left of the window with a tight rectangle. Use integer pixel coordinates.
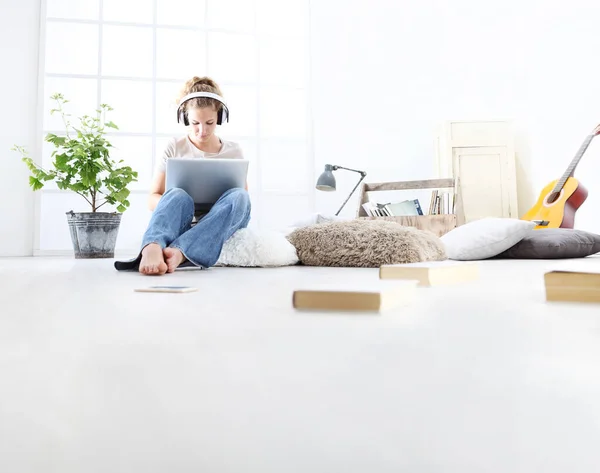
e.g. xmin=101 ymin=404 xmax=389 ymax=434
xmin=0 ymin=0 xmax=40 ymax=256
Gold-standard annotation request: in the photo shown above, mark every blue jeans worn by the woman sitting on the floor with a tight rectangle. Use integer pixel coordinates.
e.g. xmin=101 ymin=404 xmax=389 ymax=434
xmin=115 ymin=188 xmax=251 ymax=270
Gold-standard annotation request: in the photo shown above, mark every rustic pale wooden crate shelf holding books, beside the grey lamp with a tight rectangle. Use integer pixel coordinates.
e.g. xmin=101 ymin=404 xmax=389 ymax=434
xmin=356 ymin=179 xmax=465 ymax=236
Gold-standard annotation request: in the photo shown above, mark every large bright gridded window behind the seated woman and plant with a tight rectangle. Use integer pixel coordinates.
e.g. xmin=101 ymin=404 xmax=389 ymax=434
xmin=36 ymin=0 xmax=314 ymax=254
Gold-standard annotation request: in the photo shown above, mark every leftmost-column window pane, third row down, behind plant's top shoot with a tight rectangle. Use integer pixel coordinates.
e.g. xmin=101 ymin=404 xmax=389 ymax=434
xmin=44 ymin=77 xmax=98 ymax=132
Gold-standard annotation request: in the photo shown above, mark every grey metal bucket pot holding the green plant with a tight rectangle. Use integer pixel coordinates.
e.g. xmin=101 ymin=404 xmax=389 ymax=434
xmin=67 ymin=210 xmax=121 ymax=259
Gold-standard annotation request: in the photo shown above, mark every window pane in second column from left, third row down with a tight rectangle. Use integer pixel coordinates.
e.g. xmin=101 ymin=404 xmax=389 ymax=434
xmin=101 ymin=79 xmax=152 ymax=133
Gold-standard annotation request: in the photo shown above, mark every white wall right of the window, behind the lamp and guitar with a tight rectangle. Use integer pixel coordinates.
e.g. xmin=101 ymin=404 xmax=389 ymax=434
xmin=311 ymin=0 xmax=600 ymax=233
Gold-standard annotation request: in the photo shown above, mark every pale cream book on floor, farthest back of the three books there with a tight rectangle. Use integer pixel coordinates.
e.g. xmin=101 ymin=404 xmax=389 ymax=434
xmin=379 ymin=260 xmax=479 ymax=286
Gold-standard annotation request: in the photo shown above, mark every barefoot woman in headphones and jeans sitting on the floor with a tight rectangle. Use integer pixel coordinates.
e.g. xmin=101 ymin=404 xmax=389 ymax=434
xmin=115 ymin=77 xmax=251 ymax=275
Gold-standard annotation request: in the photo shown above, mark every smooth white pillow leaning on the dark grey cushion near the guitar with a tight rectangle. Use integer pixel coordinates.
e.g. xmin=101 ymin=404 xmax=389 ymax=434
xmin=440 ymin=217 xmax=536 ymax=261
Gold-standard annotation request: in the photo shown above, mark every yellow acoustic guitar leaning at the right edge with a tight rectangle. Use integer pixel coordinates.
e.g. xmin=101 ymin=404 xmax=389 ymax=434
xmin=521 ymin=125 xmax=600 ymax=230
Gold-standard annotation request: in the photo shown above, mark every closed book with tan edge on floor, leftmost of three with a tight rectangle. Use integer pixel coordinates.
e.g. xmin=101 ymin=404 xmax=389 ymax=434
xmin=292 ymin=281 xmax=416 ymax=312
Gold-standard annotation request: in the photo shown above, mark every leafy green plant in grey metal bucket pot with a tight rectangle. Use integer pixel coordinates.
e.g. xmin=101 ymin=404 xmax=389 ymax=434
xmin=11 ymin=93 xmax=138 ymax=258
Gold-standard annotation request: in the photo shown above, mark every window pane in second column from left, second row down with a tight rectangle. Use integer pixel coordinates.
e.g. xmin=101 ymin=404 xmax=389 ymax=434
xmin=102 ymin=26 xmax=153 ymax=77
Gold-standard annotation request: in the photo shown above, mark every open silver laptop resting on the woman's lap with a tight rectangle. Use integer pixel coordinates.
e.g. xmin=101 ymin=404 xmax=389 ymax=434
xmin=165 ymin=158 xmax=249 ymax=208
